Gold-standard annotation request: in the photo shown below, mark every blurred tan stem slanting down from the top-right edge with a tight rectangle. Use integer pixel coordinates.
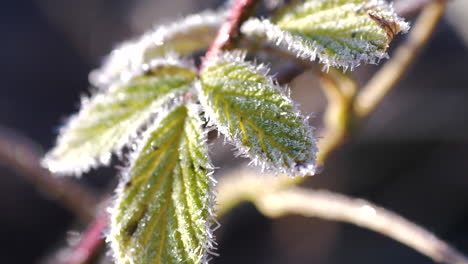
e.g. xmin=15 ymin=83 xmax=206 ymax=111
xmin=355 ymin=0 xmax=446 ymax=118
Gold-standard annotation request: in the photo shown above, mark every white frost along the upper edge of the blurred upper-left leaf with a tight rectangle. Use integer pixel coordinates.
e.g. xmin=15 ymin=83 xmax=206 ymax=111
xmin=89 ymin=9 xmax=227 ymax=88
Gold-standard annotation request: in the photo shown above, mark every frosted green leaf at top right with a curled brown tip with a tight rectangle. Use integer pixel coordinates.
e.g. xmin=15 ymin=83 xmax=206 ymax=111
xmin=242 ymin=0 xmax=409 ymax=69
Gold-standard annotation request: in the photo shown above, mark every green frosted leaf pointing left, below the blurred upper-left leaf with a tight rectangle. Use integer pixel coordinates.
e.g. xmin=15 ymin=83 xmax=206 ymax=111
xmin=43 ymin=61 xmax=196 ymax=174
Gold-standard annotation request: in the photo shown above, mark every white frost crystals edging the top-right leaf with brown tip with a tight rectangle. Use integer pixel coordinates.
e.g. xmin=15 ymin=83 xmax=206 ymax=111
xmin=241 ymin=0 xmax=410 ymax=71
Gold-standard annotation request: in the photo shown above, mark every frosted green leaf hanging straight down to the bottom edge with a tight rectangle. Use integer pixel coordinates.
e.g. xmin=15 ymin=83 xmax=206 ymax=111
xmin=108 ymin=105 xmax=213 ymax=264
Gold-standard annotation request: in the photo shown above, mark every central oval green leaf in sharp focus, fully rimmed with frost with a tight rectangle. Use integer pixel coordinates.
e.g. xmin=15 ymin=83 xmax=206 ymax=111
xmin=197 ymin=52 xmax=317 ymax=176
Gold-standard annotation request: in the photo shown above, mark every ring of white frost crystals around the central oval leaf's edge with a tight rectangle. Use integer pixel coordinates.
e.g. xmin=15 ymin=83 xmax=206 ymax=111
xmin=195 ymin=50 xmax=318 ymax=177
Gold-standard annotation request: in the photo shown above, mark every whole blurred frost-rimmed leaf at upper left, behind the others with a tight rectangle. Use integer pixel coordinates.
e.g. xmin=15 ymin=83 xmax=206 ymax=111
xmin=89 ymin=10 xmax=226 ymax=88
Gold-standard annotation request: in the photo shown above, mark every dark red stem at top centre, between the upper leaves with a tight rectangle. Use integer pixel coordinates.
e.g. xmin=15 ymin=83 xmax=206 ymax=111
xmin=200 ymin=0 xmax=259 ymax=68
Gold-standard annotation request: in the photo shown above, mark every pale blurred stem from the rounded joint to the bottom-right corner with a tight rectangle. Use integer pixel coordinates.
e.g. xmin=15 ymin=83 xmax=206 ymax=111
xmin=256 ymin=187 xmax=468 ymax=264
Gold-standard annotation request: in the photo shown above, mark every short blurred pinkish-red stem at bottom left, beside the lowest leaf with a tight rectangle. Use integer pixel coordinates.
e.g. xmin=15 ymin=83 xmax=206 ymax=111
xmin=65 ymin=213 xmax=109 ymax=264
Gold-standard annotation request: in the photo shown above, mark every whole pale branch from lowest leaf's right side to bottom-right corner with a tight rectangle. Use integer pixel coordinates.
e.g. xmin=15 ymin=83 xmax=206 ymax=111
xmin=217 ymin=169 xmax=468 ymax=264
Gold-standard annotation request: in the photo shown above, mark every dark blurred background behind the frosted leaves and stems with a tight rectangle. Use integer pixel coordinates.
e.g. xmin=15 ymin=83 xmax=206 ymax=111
xmin=0 ymin=0 xmax=468 ymax=264
